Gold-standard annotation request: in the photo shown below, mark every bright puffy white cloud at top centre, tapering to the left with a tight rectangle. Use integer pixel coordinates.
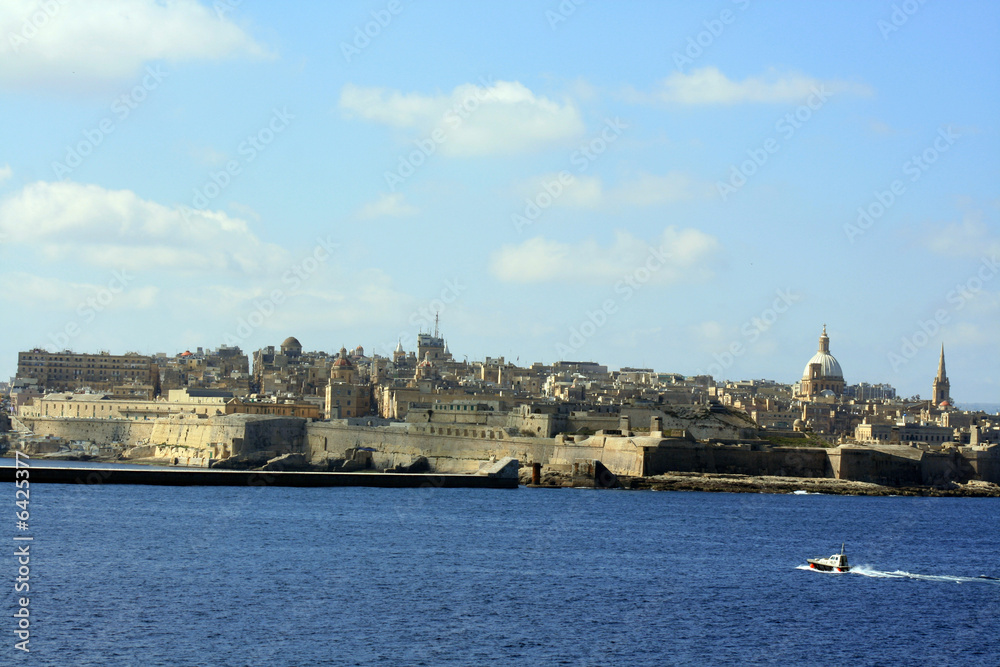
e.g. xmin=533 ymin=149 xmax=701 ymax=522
xmin=340 ymin=81 xmax=584 ymax=156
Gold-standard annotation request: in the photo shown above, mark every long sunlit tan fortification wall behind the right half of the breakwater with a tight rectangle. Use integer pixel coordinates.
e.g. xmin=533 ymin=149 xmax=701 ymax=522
xmin=306 ymin=420 xmax=554 ymax=473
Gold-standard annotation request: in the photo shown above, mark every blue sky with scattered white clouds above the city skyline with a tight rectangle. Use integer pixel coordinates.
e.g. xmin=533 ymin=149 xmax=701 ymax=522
xmin=0 ymin=0 xmax=1000 ymax=405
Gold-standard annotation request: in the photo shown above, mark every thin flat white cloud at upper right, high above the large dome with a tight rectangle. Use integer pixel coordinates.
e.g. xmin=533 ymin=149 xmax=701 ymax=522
xmin=626 ymin=67 xmax=871 ymax=105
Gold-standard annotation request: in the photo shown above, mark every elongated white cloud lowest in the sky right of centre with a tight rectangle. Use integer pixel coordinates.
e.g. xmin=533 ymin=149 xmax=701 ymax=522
xmin=490 ymin=227 xmax=719 ymax=285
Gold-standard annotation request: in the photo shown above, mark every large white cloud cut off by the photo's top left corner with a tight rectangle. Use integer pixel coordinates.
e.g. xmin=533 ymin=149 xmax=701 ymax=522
xmin=0 ymin=0 xmax=270 ymax=90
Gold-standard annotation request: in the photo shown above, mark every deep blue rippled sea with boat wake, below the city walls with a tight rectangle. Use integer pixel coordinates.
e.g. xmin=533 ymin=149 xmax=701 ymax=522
xmin=0 ymin=462 xmax=1000 ymax=666
